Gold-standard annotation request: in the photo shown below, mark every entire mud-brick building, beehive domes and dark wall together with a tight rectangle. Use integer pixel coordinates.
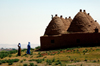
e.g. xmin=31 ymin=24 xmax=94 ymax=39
xmin=40 ymin=9 xmax=100 ymax=50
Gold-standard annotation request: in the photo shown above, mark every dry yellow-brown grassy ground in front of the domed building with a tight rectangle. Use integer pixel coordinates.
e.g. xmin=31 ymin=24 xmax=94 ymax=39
xmin=0 ymin=47 xmax=100 ymax=66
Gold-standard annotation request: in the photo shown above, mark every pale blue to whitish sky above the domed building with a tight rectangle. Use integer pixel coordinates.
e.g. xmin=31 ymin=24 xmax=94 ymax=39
xmin=0 ymin=0 xmax=100 ymax=48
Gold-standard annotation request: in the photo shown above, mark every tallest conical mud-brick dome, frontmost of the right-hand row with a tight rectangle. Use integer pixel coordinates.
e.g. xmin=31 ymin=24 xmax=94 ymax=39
xmin=68 ymin=11 xmax=91 ymax=32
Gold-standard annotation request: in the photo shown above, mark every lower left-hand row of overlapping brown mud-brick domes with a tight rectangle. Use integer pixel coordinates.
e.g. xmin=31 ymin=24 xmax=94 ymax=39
xmin=44 ymin=14 xmax=72 ymax=35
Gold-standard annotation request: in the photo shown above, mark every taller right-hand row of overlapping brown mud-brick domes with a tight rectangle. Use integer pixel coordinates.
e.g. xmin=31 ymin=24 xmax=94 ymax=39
xmin=68 ymin=10 xmax=100 ymax=32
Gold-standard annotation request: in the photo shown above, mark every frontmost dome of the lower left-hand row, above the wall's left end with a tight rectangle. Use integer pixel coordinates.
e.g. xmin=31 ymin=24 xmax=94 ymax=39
xmin=45 ymin=15 xmax=65 ymax=35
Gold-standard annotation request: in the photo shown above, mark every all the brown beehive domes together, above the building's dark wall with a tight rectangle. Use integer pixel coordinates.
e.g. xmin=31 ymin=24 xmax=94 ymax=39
xmin=44 ymin=9 xmax=100 ymax=35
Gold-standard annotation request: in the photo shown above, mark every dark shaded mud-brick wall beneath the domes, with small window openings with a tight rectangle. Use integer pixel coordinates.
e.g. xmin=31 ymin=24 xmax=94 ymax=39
xmin=40 ymin=33 xmax=100 ymax=50
